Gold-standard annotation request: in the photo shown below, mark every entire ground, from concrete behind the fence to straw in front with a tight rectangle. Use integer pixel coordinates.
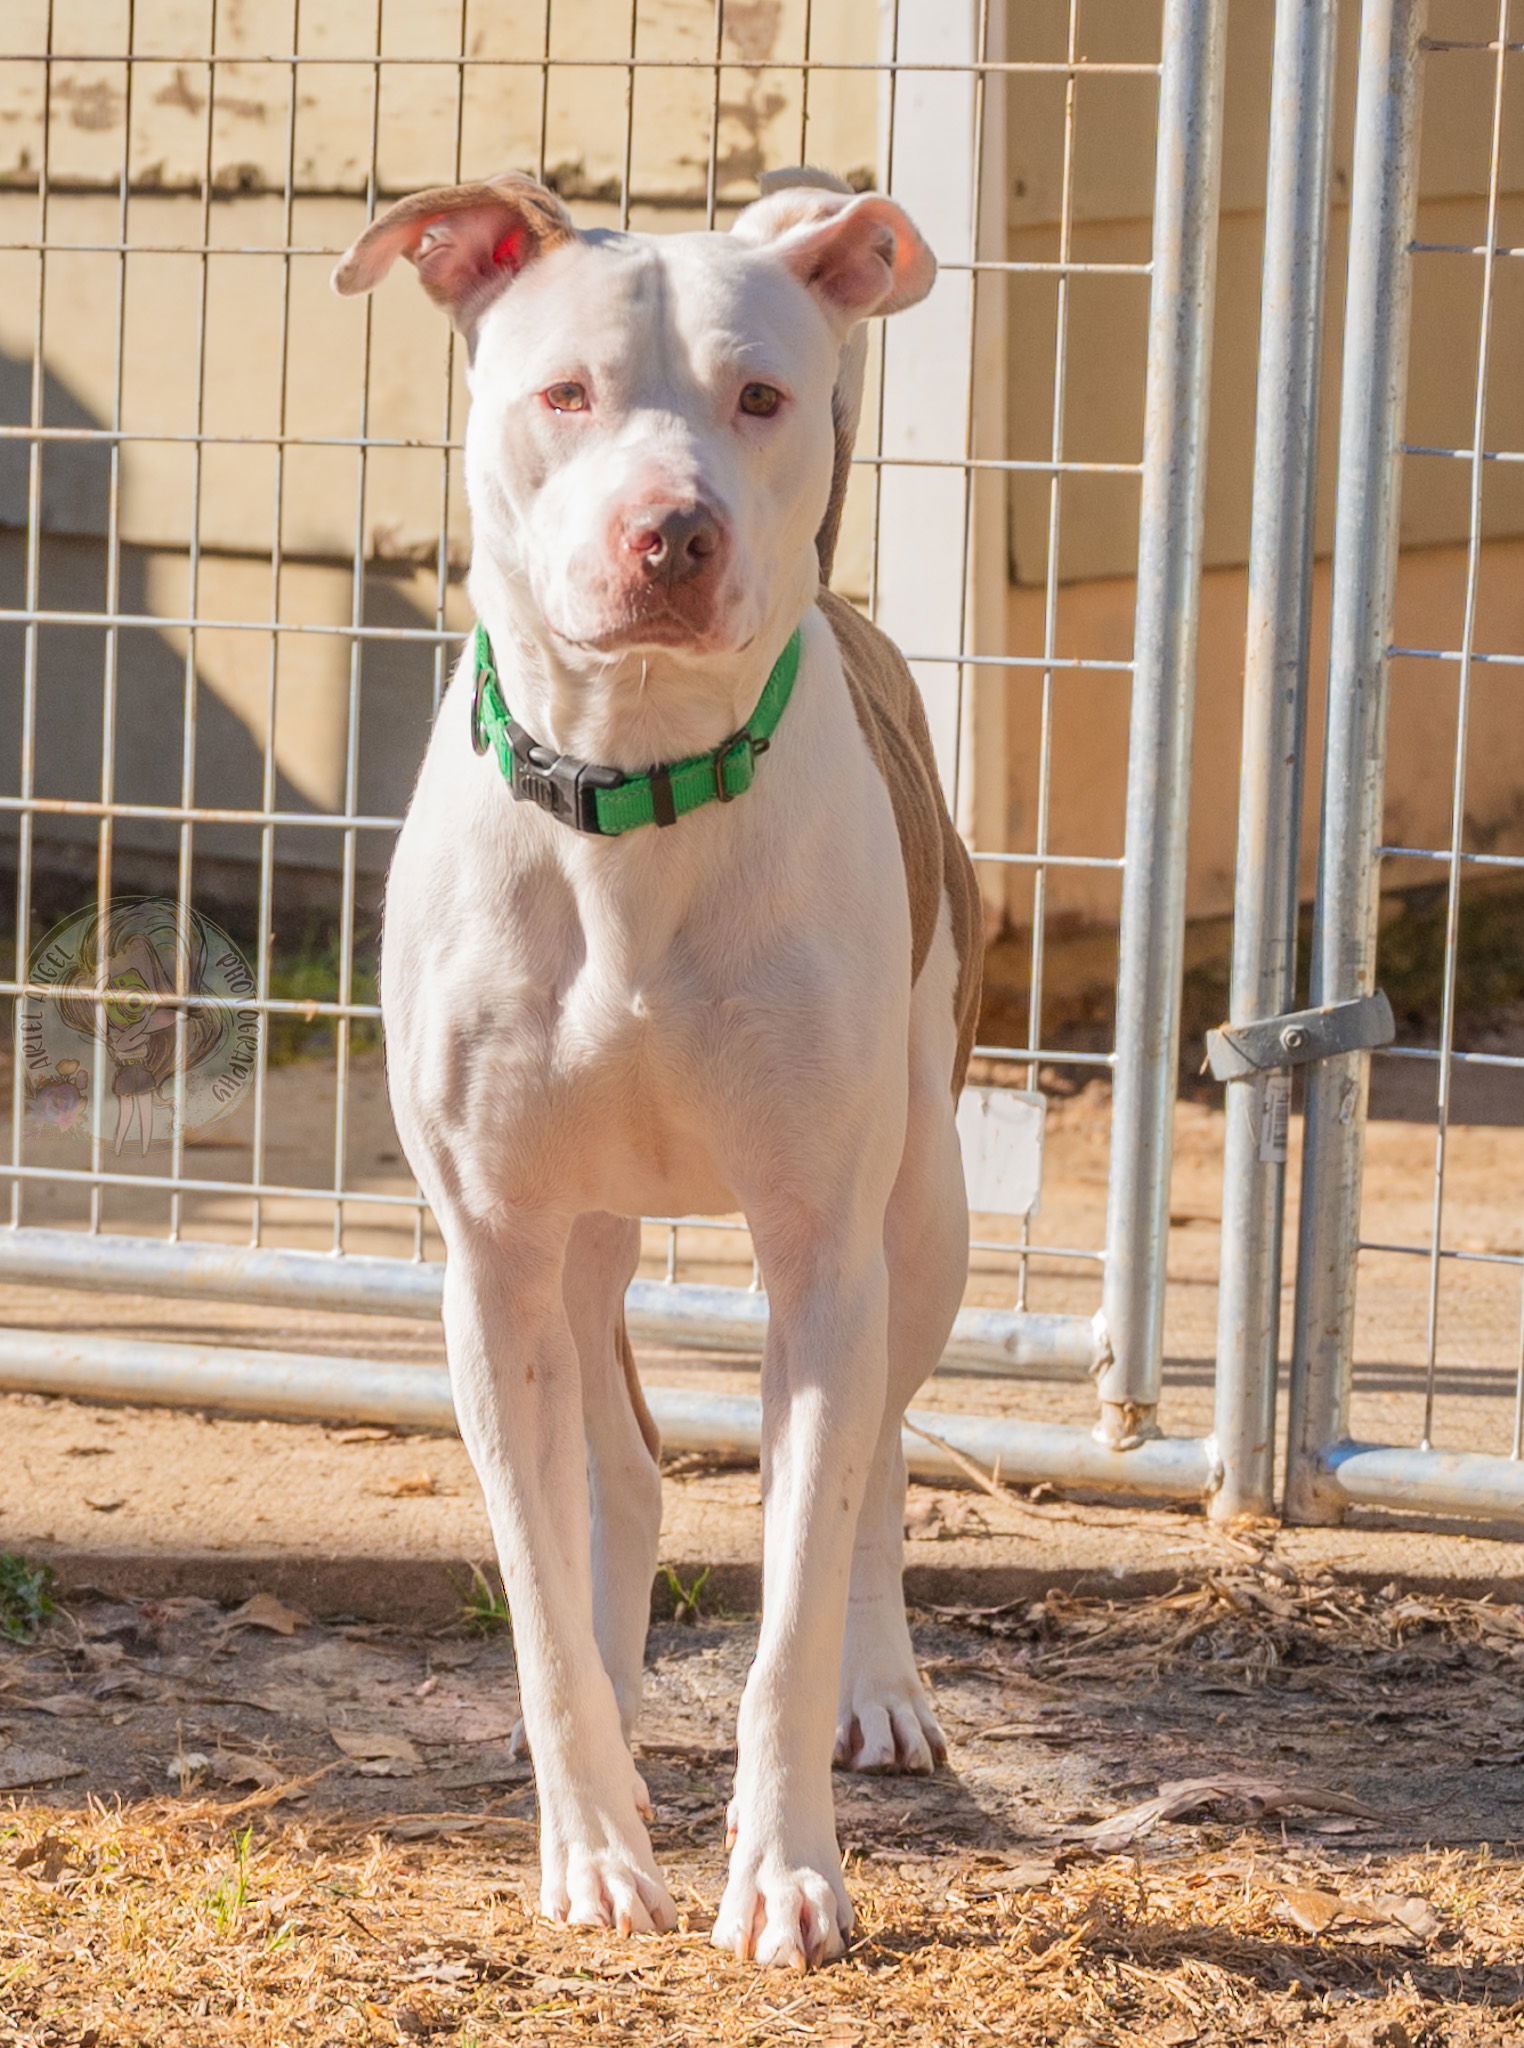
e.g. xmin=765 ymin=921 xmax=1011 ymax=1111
xmin=0 ymin=1059 xmax=1524 ymax=2048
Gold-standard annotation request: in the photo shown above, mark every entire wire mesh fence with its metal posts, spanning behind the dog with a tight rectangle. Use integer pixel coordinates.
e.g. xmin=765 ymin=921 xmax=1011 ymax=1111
xmin=0 ymin=0 xmax=1524 ymax=1511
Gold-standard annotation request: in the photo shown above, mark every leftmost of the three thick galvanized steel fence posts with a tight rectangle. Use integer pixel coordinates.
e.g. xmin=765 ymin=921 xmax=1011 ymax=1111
xmin=1096 ymin=0 xmax=1227 ymax=1446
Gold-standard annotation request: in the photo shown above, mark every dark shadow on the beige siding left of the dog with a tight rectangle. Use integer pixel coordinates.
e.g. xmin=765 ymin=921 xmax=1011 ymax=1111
xmin=0 ymin=352 xmax=444 ymax=928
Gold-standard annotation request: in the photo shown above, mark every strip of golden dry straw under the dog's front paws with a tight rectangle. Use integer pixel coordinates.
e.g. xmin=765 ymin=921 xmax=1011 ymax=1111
xmin=0 ymin=1800 xmax=1524 ymax=2048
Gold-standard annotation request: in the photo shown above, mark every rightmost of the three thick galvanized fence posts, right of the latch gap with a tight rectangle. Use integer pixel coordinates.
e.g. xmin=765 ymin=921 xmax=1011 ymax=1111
xmin=1286 ymin=0 xmax=1424 ymax=1522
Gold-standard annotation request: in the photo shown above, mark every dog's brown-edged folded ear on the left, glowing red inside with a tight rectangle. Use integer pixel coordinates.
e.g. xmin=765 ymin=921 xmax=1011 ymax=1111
xmin=332 ymin=170 xmax=576 ymax=330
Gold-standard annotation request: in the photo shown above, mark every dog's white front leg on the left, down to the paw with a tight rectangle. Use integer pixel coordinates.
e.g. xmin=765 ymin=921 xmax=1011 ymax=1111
xmin=445 ymin=1219 xmax=678 ymax=1933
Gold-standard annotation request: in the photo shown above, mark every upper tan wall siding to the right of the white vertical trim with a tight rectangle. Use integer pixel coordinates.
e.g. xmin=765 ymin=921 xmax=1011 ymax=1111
xmin=1008 ymin=0 xmax=1524 ymax=584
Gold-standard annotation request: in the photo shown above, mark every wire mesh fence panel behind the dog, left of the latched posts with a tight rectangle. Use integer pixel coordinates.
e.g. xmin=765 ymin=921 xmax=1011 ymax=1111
xmin=0 ymin=0 xmax=1245 ymax=1491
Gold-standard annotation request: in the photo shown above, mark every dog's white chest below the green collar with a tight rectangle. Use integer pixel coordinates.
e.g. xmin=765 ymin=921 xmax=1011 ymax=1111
xmin=381 ymin=629 xmax=942 ymax=1214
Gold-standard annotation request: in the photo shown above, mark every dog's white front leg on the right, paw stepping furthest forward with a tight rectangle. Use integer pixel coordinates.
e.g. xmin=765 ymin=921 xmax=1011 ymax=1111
xmin=713 ymin=1217 xmax=889 ymax=1968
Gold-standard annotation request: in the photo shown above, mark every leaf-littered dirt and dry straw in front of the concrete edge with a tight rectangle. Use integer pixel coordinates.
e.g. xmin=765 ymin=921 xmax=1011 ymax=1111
xmin=0 ymin=1540 xmax=1524 ymax=2048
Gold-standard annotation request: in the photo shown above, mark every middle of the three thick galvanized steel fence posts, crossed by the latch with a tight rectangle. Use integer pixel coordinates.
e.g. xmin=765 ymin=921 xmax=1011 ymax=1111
xmin=1211 ymin=0 xmax=1338 ymax=1520
